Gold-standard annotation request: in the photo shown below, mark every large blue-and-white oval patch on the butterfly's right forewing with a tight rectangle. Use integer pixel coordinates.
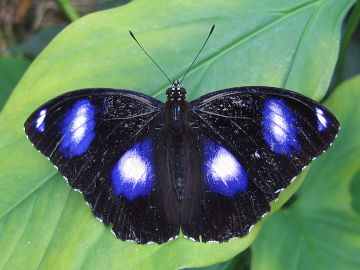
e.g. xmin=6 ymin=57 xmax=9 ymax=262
xmin=262 ymin=98 xmax=300 ymax=156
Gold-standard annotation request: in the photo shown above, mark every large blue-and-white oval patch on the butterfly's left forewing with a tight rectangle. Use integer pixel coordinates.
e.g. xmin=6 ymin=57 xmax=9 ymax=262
xmin=59 ymin=99 xmax=96 ymax=158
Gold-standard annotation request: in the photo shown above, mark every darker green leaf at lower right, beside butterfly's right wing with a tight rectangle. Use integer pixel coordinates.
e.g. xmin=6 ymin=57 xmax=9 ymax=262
xmin=251 ymin=75 xmax=360 ymax=270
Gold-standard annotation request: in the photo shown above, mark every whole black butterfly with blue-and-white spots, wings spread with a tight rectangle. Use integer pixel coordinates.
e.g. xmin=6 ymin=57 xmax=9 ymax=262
xmin=24 ymin=25 xmax=339 ymax=244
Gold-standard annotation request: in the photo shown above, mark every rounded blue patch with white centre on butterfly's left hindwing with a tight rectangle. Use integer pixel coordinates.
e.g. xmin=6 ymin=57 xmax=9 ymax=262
xmin=111 ymin=138 xmax=155 ymax=200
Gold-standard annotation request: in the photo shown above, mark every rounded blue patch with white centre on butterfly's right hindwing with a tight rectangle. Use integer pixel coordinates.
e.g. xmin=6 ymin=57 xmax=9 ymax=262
xmin=203 ymin=137 xmax=248 ymax=197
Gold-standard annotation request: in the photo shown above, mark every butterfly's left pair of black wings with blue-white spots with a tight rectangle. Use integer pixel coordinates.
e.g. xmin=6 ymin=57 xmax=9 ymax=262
xmin=25 ymin=89 xmax=179 ymax=243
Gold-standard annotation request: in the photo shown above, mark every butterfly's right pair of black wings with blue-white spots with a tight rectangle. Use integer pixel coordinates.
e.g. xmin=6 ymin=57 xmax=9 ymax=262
xmin=182 ymin=86 xmax=339 ymax=242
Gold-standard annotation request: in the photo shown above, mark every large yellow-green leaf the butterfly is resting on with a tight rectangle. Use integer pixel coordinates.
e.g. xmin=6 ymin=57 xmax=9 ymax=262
xmin=0 ymin=0 xmax=354 ymax=269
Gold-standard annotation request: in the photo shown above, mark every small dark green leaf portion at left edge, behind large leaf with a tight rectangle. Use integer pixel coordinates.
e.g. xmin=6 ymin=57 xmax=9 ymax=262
xmin=0 ymin=57 xmax=31 ymax=111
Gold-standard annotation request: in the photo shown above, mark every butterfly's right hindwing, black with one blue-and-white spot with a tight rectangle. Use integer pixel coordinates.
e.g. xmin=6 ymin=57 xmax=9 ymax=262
xmin=181 ymin=132 xmax=270 ymax=242
